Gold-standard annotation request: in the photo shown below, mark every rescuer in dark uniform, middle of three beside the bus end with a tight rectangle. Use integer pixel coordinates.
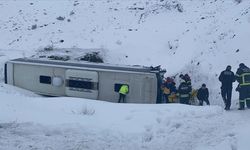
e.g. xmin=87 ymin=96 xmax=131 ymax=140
xmin=178 ymin=79 xmax=192 ymax=104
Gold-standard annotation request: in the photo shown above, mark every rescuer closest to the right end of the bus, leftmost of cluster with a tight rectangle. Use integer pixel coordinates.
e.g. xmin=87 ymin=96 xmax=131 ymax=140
xmin=163 ymin=77 xmax=176 ymax=103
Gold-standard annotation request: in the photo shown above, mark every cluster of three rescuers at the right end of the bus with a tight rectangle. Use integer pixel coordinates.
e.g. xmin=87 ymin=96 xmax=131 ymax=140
xmin=162 ymin=74 xmax=210 ymax=106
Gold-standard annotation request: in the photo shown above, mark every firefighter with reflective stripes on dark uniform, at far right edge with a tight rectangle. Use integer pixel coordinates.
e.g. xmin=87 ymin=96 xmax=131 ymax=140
xmin=235 ymin=63 xmax=250 ymax=110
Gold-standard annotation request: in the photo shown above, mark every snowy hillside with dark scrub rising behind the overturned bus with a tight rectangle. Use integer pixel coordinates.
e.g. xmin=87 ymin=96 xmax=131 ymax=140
xmin=0 ymin=0 xmax=250 ymax=104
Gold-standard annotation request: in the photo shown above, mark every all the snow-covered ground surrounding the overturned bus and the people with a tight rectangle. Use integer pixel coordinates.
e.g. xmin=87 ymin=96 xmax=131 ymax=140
xmin=0 ymin=0 xmax=250 ymax=150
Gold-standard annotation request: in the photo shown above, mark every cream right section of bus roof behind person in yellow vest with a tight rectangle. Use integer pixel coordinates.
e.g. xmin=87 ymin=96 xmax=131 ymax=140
xmin=99 ymin=72 xmax=157 ymax=103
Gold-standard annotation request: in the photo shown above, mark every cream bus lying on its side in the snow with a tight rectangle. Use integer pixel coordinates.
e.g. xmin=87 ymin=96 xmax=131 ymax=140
xmin=4 ymin=58 xmax=165 ymax=103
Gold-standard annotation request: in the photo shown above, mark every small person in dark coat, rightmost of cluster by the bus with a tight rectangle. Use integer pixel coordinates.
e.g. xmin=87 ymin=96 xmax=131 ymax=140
xmin=197 ymin=83 xmax=210 ymax=106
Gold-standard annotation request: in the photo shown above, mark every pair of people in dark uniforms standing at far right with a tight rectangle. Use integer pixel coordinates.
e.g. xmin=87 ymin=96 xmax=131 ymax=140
xmin=219 ymin=63 xmax=250 ymax=110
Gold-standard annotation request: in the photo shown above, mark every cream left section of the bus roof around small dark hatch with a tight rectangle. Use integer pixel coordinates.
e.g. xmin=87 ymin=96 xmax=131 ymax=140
xmin=14 ymin=64 xmax=65 ymax=96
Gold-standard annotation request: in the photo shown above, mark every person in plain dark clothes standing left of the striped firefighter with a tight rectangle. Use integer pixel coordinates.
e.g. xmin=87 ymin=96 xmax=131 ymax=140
xmin=219 ymin=65 xmax=235 ymax=110
